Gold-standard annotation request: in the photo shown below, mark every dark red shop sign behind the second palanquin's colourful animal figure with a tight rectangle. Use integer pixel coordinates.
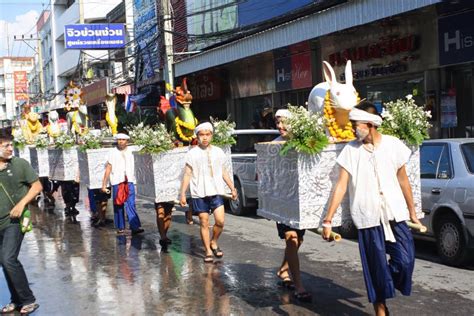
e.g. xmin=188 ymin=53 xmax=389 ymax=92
xmin=189 ymin=73 xmax=222 ymax=101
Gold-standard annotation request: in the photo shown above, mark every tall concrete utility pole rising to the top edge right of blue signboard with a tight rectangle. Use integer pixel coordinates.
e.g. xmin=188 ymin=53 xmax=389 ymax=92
xmin=161 ymin=0 xmax=174 ymax=97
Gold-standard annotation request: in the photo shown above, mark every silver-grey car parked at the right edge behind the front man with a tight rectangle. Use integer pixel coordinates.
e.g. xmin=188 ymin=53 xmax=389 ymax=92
xmin=415 ymin=138 xmax=474 ymax=266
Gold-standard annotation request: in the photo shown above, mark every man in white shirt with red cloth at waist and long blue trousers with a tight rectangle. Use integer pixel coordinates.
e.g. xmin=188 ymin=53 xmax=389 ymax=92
xmin=102 ymin=133 xmax=144 ymax=235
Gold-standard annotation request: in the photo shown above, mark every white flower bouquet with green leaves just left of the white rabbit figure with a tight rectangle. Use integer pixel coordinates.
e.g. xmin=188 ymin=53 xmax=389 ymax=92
xmin=280 ymin=106 xmax=329 ymax=156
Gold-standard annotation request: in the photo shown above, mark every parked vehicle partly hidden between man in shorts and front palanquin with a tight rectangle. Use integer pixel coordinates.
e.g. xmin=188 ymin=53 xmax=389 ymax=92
xmin=229 ymin=129 xmax=279 ymax=215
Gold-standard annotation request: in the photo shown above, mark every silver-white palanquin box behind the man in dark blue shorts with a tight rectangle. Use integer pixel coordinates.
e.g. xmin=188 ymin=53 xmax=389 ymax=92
xmin=134 ymin=147 xmax=232 ymax=202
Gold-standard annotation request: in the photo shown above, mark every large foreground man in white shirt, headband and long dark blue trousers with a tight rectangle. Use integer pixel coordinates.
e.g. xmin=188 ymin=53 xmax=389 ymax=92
xmin=322 ymin=107 xmax=420 ymax=316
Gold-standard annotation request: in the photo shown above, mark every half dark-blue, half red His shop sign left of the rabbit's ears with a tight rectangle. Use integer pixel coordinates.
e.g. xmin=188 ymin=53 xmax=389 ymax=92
xmin=275 ymin=52 xmax=313 ymax=91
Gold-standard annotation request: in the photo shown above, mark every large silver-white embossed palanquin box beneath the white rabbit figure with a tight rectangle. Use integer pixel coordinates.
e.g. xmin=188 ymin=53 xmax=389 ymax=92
xmin=255 ymin=143 xmax=423 ymax=229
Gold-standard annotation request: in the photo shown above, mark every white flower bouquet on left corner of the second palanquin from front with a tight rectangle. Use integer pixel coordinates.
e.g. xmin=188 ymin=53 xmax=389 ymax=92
xmin=126 ymin=123 xmax=174 ymax=154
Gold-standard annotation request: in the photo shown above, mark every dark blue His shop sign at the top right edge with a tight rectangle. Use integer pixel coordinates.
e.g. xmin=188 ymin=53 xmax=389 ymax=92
xmin=438 ymin=11 xmax=474 ymax=66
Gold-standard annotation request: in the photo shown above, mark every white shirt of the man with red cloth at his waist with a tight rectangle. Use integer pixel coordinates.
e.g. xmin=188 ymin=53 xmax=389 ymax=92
xmin=107 ymin=147 xmax=136 ymax=185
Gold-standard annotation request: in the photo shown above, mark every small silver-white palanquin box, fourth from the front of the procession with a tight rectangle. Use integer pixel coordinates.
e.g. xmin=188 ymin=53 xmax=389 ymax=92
xmin=48 ymin=147 xmax=79 ymax=181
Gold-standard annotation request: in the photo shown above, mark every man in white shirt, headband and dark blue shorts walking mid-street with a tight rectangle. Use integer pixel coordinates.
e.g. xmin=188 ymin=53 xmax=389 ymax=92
xmin=180 ymin=122 xmax=237 ymax=263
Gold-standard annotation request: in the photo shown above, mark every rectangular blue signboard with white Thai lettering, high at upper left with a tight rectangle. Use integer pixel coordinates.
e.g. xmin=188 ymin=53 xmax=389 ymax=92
xmin=64 ymin=23 xmax=125 ymax=49
